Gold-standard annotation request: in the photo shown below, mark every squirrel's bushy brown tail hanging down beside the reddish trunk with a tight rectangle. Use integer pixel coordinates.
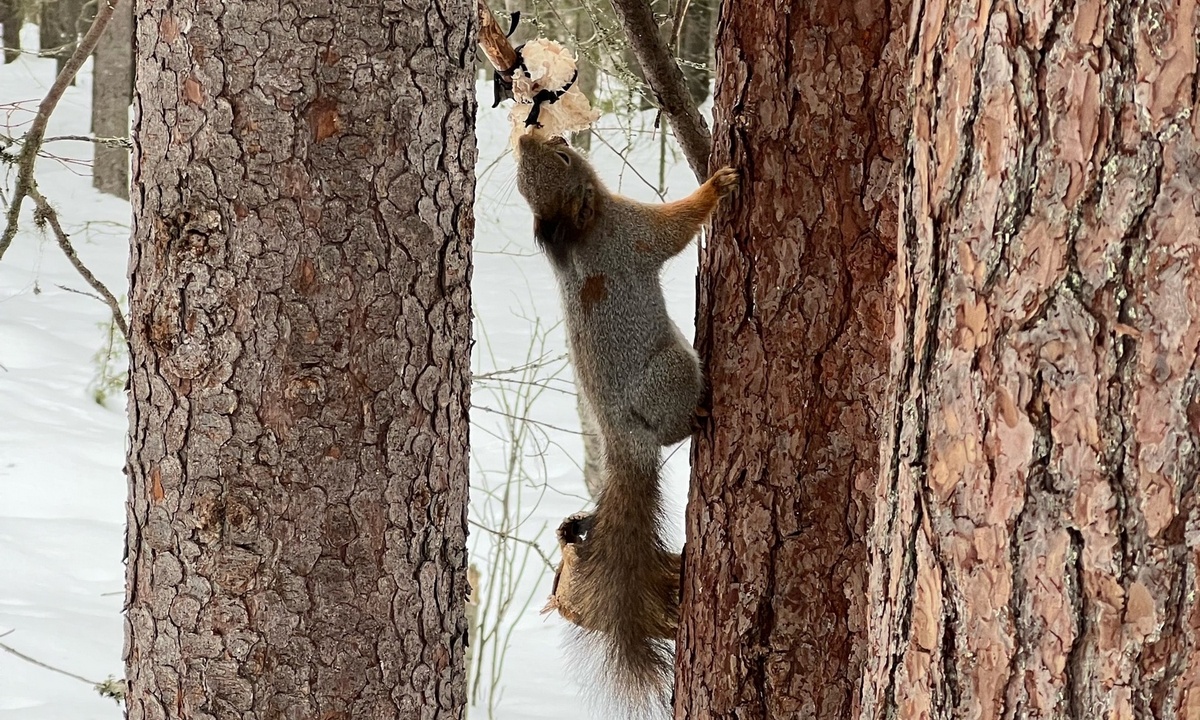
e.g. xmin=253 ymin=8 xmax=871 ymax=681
xmin=577 ymin=436 xmax=679 ymax=715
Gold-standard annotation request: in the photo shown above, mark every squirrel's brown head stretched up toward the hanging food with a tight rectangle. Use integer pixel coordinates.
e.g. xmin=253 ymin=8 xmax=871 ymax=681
xmin=517 ymin=134 xmax=604 ymax=245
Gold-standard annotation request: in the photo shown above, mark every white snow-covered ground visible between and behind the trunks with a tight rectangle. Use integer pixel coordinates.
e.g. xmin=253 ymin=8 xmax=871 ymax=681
xmin=0 ymin=25 xmax=696 ymax=720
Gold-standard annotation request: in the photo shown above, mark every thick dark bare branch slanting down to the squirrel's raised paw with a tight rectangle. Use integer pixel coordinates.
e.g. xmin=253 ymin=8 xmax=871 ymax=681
xmin=612 ymin=0 xmax=713 ymax=182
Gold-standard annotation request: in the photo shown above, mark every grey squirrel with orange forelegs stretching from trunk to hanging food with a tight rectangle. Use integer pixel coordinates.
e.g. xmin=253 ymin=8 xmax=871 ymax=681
xmin=516 ymin=134 xmax=738 ymax=714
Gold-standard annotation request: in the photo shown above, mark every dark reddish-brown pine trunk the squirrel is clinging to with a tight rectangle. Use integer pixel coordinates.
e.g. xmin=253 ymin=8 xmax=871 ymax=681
xmin=676 ymin=1 xmax=908 ymax=720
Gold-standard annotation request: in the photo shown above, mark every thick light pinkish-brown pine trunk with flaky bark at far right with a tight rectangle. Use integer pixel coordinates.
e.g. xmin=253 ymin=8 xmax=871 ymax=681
xmin=862 ymin=0 xmax=1200 ymax=720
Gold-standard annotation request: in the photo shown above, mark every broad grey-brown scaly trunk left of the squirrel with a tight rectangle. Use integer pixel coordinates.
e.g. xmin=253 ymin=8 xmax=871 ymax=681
xmin=126 ymin=0 xmax=476 ymax=720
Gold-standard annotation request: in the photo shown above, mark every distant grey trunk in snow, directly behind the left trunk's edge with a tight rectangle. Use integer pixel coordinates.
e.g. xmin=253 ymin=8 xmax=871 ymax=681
xmin=91 ymin=0 xmax=133 ymax=199
